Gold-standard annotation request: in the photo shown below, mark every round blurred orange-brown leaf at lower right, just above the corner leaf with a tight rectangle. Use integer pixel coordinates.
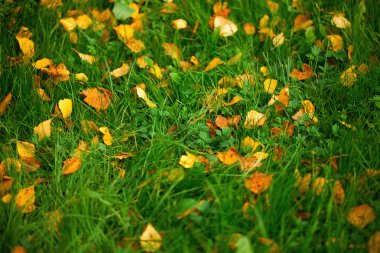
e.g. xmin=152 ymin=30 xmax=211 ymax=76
xmin=346 ymin=204 xmax=376 ymax=229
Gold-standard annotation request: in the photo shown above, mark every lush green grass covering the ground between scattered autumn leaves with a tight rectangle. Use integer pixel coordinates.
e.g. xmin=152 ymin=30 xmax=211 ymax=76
xmin=0 ymin=0 xmax=380 ymax=252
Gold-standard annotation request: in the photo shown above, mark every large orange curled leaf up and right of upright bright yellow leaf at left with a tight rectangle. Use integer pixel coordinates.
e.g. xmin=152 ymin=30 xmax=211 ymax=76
xmin=80 ymin=88 xmax=112 ymax=112
